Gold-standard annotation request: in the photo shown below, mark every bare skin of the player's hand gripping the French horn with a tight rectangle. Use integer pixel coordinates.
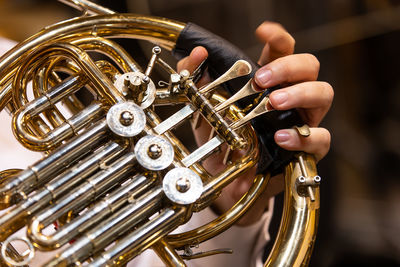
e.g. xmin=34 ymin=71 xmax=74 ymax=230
xmin=178 ymin=22 xmax=334 ymax=226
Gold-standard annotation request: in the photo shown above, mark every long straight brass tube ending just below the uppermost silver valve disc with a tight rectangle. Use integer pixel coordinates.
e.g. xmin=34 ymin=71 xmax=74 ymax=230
xmin=0 ymin=143 xmax=125 ymax=241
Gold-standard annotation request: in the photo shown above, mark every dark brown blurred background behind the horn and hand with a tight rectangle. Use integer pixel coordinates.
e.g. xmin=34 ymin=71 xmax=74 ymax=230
xmin=0 ymin=0 xmax=400 ymax=266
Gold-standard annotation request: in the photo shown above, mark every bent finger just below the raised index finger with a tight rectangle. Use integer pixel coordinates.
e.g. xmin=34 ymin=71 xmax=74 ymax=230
xmin=254 ymin=54 xmax=320 ymax=88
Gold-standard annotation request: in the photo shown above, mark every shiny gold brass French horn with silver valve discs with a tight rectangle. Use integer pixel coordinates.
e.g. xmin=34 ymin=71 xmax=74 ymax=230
xmin=0 ymin=0 xmax=320 ymax=266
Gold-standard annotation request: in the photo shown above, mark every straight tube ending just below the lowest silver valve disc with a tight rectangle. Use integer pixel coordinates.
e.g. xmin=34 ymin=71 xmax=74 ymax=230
xmin=90 ymin=207 xmax=186 ymax=267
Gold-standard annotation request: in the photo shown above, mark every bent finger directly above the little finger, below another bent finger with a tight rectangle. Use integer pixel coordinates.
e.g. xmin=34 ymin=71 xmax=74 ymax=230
xmin=269 ymin=81 xmax=334 ymax=127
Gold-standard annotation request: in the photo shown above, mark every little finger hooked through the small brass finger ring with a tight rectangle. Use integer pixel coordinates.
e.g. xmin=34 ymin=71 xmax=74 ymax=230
xmin=274 ymin=128 xmax=331 ymax=161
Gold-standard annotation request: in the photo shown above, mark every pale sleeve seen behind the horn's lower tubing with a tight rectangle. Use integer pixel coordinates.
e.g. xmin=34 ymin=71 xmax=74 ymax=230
xmin=128 ymin=199 xmax=274 ymax=267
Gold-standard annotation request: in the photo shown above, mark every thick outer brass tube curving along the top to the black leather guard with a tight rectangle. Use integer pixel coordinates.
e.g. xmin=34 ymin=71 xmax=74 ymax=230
xmin=0 ymin=14 xmax=185 ymax=110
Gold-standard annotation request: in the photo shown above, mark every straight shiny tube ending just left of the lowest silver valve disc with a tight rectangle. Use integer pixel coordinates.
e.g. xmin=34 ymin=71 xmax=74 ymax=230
xmin=44 ymin=187 xmax=163 ymax=266
